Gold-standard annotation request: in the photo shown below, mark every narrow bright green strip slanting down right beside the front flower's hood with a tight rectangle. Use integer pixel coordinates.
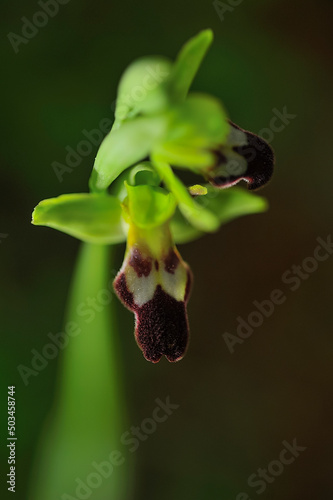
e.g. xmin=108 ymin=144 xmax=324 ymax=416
xmin=153 ymin=161 xmax=219 ymax=232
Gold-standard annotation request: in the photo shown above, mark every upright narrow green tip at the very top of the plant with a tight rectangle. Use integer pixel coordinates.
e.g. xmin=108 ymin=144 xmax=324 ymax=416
xmin=167 ymin=30 xmax=213 ymax=101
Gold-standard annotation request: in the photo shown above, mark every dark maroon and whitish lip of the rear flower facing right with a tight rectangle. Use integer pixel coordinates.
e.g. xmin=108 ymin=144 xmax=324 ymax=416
xmin=208 ymin=122 xmax=275 ymax=190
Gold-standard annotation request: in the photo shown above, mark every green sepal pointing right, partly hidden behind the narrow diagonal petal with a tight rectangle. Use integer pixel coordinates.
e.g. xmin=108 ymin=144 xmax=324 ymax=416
xmin=171 ymin=186 xmax=268 ymax=243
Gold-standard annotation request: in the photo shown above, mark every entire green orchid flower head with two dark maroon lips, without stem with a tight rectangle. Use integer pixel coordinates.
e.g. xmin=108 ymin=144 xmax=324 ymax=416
xmin=33 ymin=30 xmax=274 ymax=363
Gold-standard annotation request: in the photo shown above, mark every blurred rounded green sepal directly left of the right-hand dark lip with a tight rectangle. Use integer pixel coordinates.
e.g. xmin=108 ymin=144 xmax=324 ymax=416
xmin=155 ymin=94 xmax=230 ymax=173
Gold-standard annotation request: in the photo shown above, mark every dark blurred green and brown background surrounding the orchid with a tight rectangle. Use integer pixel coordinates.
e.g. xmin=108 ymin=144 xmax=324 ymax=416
xmin=0 ymin=0 xmax=333 ymax=500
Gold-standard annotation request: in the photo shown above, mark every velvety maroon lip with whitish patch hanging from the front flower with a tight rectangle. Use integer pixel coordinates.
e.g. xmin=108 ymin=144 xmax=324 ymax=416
xmin=114 ymin=227 xmax=192 ymax=363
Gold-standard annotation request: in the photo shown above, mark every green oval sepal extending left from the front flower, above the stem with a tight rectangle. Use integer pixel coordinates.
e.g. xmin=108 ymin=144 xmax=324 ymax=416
xmin=32 ymin=193 xmax=126 ymax=244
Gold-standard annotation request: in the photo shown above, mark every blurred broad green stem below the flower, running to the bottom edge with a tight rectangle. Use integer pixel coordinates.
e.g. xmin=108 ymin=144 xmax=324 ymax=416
xmin=31 ymin=244 xmax=130 ymax=500
